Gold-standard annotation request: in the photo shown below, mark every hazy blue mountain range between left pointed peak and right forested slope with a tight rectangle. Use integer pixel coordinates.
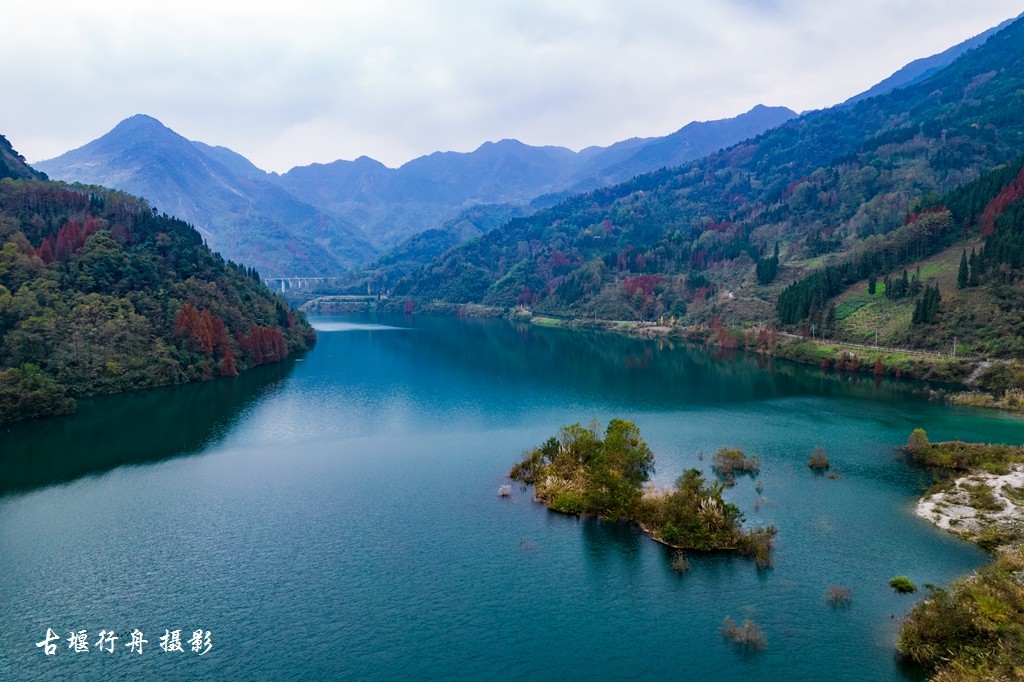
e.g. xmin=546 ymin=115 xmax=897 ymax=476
xmin=272 ymin=105 xmax=796 ymax=250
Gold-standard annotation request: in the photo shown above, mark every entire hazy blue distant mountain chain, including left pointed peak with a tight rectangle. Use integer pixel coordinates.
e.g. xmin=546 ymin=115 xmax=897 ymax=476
xmin=37 ymin=105 xmax=795 ymax=276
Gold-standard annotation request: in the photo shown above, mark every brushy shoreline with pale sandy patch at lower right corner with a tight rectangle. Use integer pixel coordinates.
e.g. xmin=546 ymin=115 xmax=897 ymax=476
xmin=893 ymin=429 xmax=1024 ymax=682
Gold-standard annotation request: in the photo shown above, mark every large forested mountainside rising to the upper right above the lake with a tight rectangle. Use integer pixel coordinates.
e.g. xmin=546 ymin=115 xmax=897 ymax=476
xmin=395 ymin=13 xmax=1024 ymax=353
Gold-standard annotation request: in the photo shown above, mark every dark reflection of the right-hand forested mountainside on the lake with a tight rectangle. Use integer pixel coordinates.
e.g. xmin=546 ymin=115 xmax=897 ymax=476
xmin=368 ymin=317 xmax=942 ymax=406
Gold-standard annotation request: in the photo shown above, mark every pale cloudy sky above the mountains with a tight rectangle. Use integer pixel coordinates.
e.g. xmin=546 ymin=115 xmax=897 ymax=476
xmin=8 ymin=0 xmax=1024 ymax=172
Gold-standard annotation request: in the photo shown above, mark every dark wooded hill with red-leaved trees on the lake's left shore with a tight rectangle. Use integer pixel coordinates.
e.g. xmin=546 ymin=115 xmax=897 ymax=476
xmin=0 ymin=134 xmax=314 ymax=424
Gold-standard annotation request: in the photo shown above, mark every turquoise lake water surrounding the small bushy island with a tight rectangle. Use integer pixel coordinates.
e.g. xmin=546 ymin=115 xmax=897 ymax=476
xmin=0 ymin=317 xmax=1024 ymax=680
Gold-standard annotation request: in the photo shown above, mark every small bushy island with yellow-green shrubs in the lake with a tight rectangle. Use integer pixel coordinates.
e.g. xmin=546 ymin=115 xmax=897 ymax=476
xmin=509 ymin=419 xmax=776 ymax=567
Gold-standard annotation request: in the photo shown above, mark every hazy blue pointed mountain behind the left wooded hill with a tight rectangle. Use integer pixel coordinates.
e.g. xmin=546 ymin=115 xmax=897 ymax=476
xmin=37 ymin=115 xmax=375 ymax=275
